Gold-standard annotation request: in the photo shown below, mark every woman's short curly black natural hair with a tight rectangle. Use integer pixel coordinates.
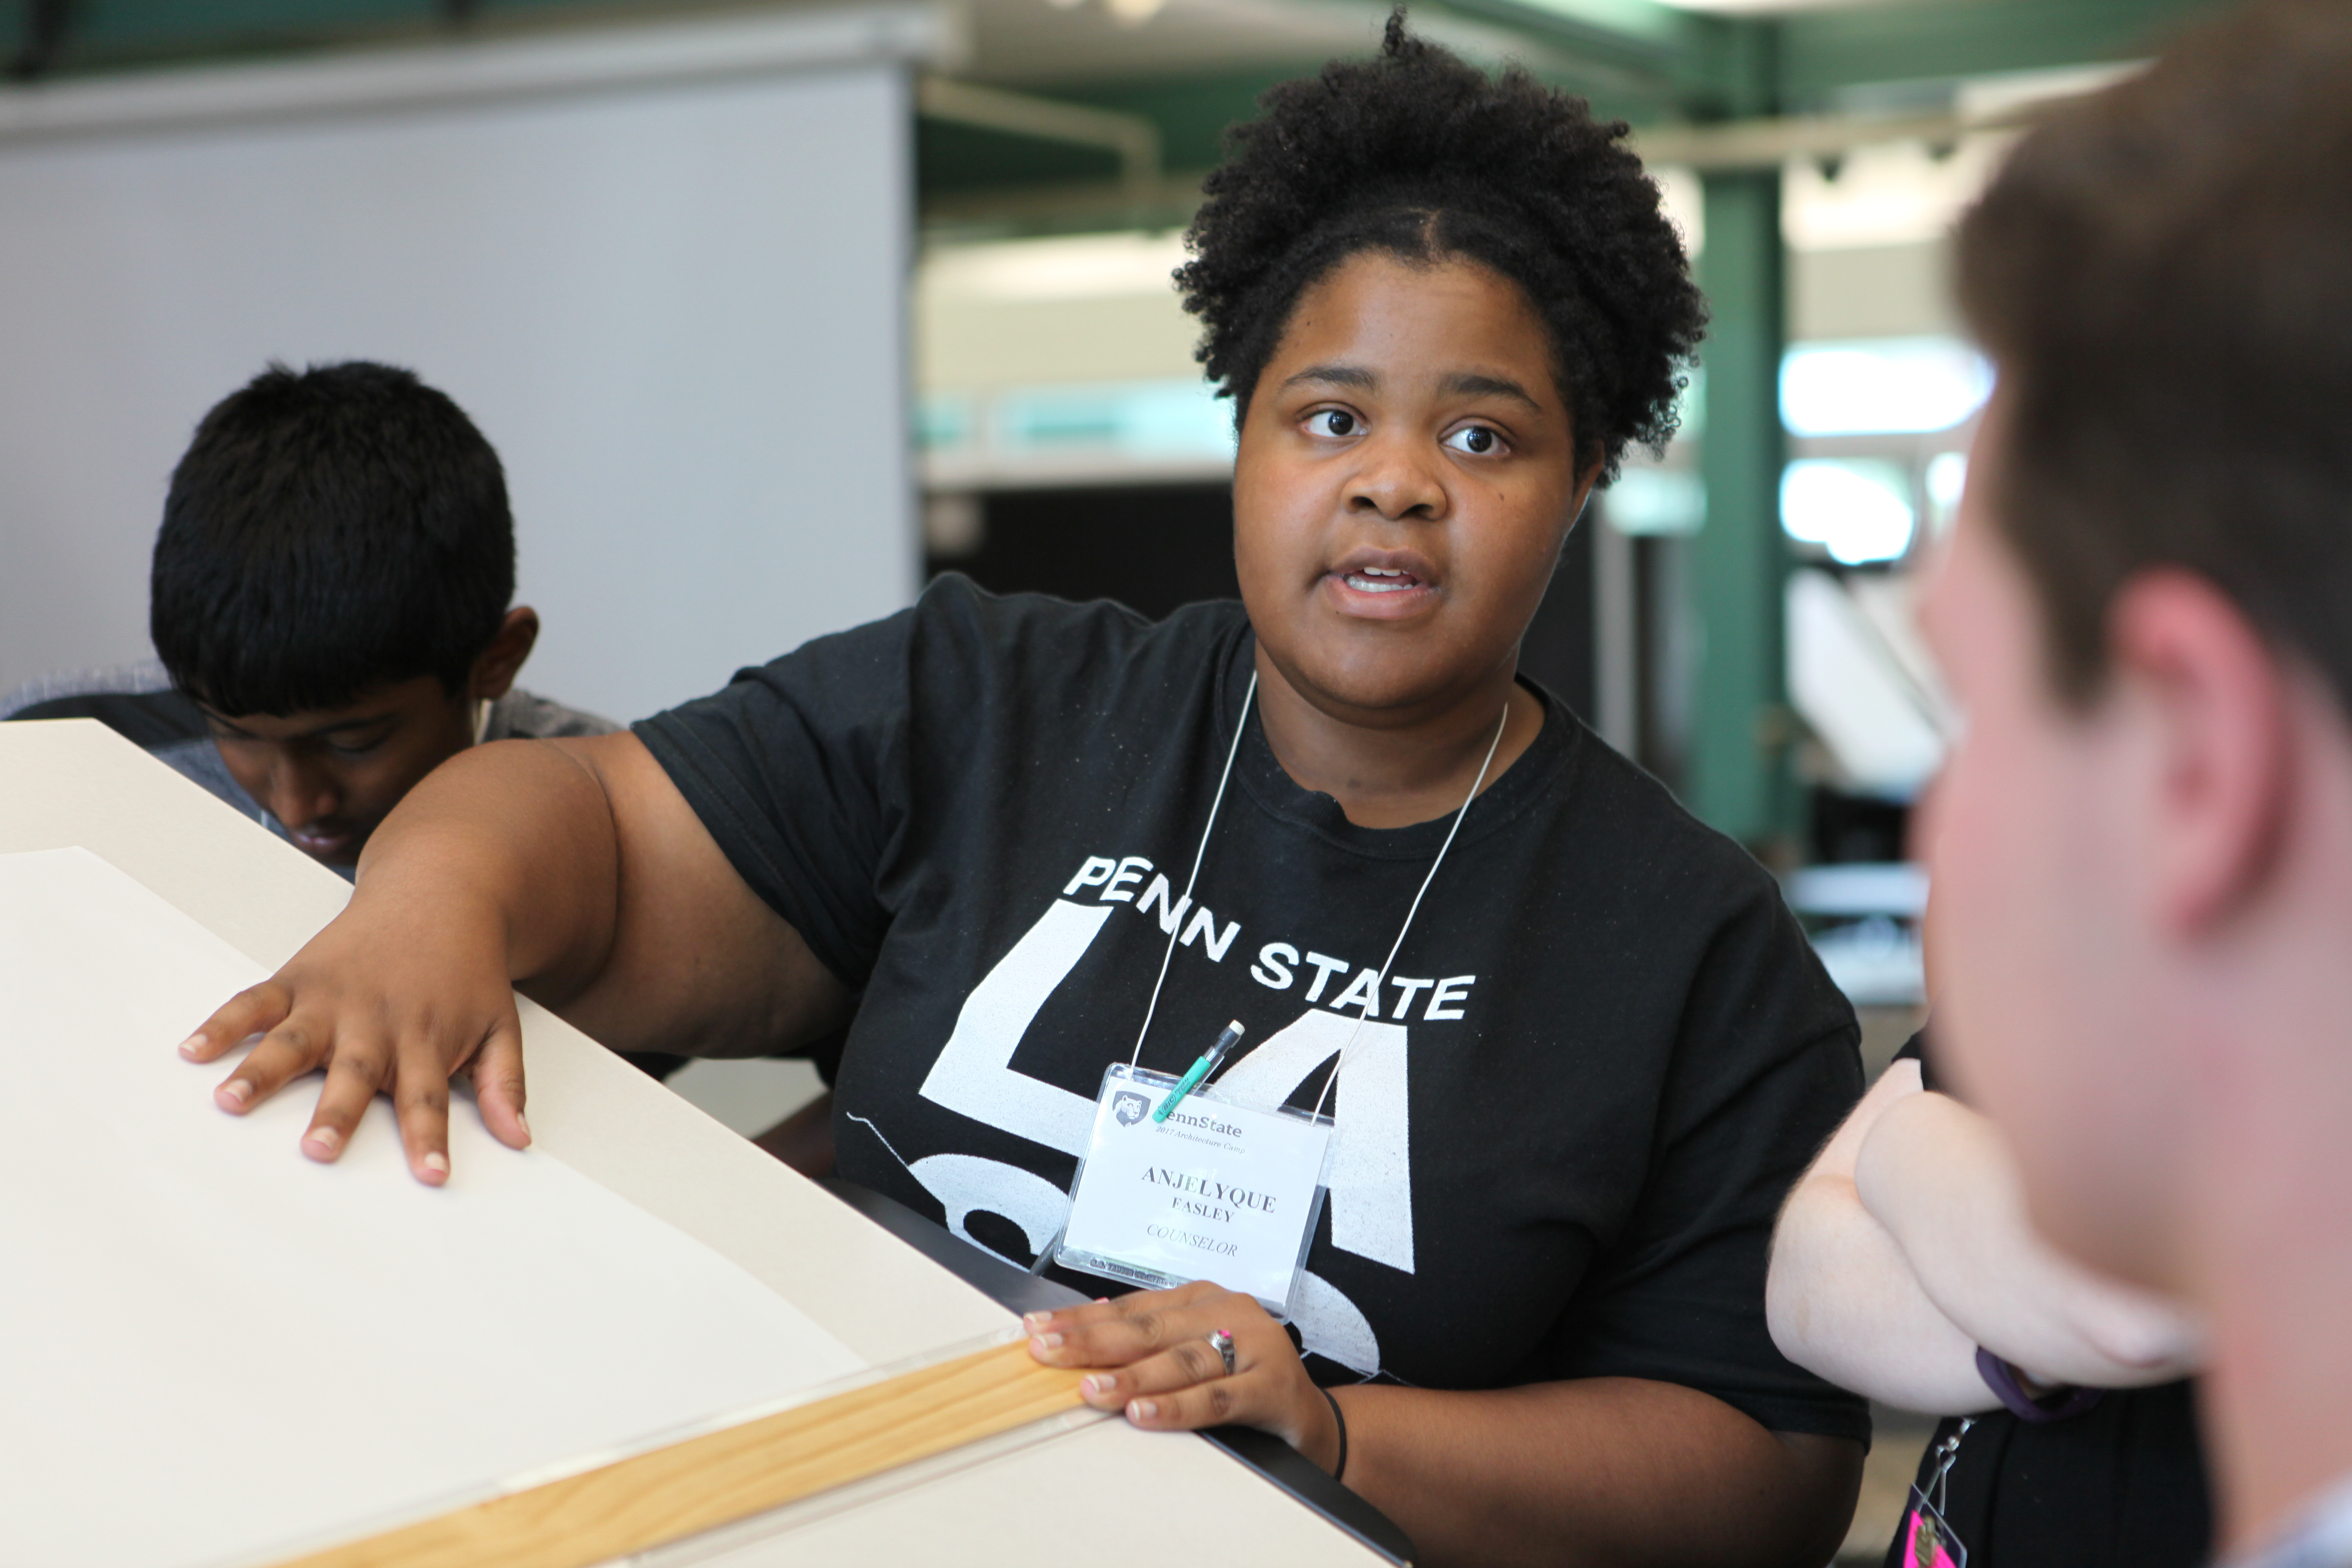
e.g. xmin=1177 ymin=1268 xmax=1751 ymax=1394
xmin=1176 ymin=9 xmax=1707 ymax=480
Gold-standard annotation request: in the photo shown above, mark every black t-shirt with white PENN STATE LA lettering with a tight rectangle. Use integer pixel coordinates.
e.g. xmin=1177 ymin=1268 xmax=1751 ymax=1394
xmin=637 ymin=578 xmax=1867 ymax=1436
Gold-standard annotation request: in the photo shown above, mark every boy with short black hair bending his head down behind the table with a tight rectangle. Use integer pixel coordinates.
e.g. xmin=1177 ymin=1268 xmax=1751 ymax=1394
xmin=14 ymin=360 xmax=611 ymax=877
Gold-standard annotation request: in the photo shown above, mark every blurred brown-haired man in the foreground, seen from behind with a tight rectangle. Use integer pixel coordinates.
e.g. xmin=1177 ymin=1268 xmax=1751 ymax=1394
xmin=1891 ymin=0 xmax=2352 ymax=1568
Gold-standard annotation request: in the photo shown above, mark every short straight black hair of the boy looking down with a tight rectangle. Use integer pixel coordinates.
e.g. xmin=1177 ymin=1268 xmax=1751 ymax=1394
xmin=148 ymin=360 xmax=515 ymax=717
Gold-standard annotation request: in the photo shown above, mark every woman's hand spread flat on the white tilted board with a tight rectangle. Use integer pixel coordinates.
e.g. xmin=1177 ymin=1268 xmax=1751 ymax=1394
xmin=179 ymin=889 xmax=531 ymax=1187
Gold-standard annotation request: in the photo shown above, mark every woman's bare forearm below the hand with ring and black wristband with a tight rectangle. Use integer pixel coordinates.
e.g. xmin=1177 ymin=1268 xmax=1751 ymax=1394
xmin=1336 ymin=1377 xmax=1863 ymax=1568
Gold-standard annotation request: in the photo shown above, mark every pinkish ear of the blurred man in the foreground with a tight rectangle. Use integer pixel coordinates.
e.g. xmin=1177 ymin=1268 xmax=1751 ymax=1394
xmin=2107 ymin=569 xmax=2295 ymax=933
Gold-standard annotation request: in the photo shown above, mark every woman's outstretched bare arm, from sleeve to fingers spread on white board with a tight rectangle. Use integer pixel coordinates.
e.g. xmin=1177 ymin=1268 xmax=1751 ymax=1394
xmin=181 ymin=731 xmax=854 ymax=1187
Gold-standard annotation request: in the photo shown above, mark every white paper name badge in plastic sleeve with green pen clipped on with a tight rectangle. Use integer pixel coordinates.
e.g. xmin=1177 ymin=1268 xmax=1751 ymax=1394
xmin=1054 ymin=1063 xmax=1331 ymax=1316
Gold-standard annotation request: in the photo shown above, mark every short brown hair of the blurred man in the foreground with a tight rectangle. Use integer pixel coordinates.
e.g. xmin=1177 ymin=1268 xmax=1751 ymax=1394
xmin=1959 ymin=0 xmax=2352 ymax=710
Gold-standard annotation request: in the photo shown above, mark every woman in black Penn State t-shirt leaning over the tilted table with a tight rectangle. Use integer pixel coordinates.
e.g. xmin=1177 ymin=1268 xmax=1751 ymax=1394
xmin=188 ymin=23 xmax=1867 ymax=1563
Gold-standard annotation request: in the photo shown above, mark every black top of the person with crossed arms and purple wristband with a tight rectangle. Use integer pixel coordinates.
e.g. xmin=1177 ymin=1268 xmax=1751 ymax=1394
xmin=1886 ymin=1032 xmax=2213 ymax=1568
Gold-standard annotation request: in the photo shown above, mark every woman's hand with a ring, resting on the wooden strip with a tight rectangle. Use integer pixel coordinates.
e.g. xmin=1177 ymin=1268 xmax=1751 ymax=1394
xmin=1023 ymin=1281 xmax=1338 ymax=1469
